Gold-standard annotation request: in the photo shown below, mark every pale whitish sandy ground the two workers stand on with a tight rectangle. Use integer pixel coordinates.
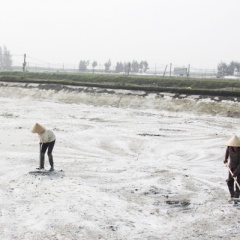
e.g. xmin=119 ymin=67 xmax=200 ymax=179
xmin=0 ymin=82 xmax=240 ymax=240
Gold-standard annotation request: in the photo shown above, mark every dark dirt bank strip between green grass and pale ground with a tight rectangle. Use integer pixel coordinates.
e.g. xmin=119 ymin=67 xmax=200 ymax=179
xmin=0 ymin=80 xmax=240 ymax=102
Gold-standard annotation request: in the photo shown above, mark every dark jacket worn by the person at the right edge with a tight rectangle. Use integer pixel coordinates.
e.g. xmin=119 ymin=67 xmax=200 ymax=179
xmin=225 ymin=147 xmax=240 ymax=175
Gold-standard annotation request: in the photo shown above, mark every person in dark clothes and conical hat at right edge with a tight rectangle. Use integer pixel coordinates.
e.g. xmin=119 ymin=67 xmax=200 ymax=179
xmin=223 ymin=135 xmax=240 ymax=198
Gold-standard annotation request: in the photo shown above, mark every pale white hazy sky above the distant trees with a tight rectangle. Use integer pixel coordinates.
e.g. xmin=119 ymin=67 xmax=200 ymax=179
xmin=0 ymin=0 xmax=240 ymax=68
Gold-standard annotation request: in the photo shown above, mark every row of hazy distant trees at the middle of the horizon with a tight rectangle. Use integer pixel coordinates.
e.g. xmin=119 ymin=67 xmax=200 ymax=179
xmin=78 ymin=59 xmax=149 ymax=74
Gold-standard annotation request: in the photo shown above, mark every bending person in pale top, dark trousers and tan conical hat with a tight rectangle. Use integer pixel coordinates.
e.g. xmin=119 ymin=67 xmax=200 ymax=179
xmin=31 ymin=123 xmax=56 ymax=171
